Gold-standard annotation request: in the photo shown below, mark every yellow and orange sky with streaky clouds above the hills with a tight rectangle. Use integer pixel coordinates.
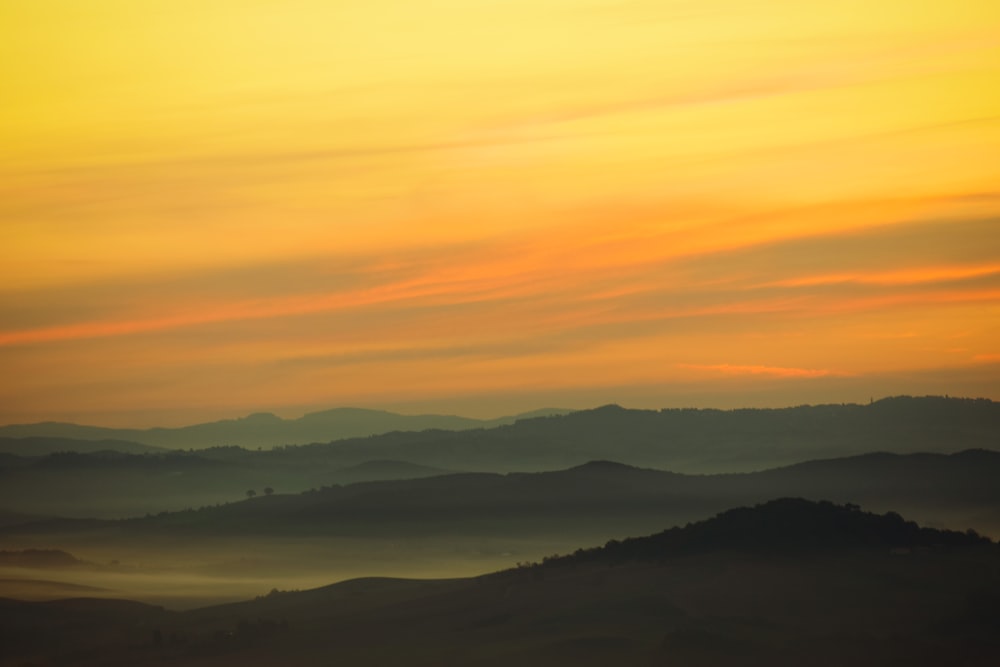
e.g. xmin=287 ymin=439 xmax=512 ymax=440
xmin=0 ymin=0 xmax=1000 ymax=426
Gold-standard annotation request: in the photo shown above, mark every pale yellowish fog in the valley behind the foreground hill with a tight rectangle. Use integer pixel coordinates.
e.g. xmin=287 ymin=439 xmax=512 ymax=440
xmin=0 ymin=536 xmax=580 ymax=609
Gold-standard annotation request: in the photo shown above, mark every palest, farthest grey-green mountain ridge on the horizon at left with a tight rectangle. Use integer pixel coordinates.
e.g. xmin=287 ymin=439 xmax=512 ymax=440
xmin=0 ymin=408 xmax=569 ymax=448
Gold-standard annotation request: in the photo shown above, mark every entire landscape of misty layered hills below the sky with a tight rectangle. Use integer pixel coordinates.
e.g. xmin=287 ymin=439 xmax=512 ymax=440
xmin=0 ymin=396 xmax=1000 ymax=666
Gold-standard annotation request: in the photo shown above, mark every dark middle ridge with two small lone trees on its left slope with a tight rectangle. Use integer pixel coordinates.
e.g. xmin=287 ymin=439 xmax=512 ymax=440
xmin=0 ymin=450 xmax=1000 ymax=537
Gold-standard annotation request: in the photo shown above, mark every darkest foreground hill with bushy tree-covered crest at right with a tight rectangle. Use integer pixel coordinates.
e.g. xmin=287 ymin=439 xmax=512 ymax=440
xmin=0 ymin=499 xmax=1000 ymax=667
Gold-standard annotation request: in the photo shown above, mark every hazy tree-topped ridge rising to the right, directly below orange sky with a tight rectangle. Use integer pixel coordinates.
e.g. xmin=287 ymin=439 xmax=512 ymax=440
xmin=225 ymin=397 xmax=1000 ymax=473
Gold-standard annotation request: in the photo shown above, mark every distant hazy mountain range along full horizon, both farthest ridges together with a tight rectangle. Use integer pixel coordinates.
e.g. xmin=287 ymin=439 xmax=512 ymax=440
xmin=0 ymin=396 xmax=1000 ymax=474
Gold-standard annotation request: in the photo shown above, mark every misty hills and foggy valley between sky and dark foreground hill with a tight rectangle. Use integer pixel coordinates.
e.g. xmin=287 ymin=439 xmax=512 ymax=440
xmin=0 ymin=397 xmax=1000 ymax=606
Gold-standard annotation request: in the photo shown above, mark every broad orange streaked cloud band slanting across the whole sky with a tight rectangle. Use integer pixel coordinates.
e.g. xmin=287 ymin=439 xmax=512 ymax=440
xmin=0 ymin=209 xmax=1000 ymax=346
